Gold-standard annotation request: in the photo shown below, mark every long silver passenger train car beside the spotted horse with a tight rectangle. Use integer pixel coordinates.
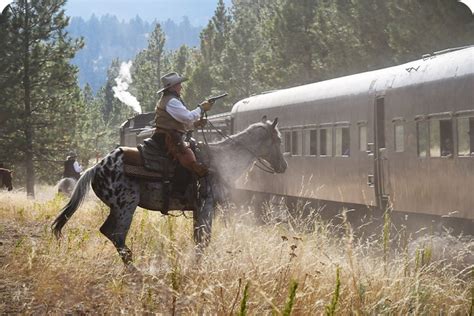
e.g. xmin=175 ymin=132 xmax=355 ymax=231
xmin=121 ymin=46 xmax=474 ymax=235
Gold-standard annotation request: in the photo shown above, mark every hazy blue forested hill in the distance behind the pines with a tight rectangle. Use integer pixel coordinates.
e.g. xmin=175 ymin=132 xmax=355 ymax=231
xmin=68 ymin=15 xmax=202 ymax=92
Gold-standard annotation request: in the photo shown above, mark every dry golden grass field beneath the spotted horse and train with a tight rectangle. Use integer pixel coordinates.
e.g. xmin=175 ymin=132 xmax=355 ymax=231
xmin=0 ymin=187 xmax=474 ymax=315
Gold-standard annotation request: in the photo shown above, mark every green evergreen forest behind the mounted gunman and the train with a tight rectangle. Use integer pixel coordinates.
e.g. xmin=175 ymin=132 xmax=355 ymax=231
xmin=0 ymin=0 xmax=474 ymax=196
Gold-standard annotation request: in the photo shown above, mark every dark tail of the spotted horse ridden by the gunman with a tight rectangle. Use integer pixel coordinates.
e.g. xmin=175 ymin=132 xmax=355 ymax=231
xmin=51 ymin=165 xmax=97 ymax=238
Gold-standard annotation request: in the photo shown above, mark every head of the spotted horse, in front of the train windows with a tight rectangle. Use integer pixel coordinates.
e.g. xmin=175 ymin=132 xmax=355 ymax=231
xmin=254 ymin=116 xmax=288 ymax=173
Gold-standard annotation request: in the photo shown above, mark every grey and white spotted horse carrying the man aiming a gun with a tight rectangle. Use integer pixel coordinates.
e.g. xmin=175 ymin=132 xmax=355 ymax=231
xmin=52 ymin=117 xmax=287 ymax=265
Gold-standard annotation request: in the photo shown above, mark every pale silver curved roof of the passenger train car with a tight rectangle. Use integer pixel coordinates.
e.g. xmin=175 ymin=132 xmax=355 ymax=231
xmin=232 ymin=46 xmax=474 ymax=114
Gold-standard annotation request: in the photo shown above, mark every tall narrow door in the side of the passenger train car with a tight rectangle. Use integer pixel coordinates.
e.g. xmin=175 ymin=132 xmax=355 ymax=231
xmin=373 ymin=95 xmax=390 ymax=211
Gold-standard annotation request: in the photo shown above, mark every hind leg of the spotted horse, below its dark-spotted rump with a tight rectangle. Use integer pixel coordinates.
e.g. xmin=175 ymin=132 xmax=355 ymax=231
xmin=100 ymin=203 xmax=137 ymax=265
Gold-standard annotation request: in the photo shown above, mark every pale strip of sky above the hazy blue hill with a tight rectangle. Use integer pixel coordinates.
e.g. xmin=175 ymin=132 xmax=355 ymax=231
xmin=63 ymin=0 xmax=231 ymax=26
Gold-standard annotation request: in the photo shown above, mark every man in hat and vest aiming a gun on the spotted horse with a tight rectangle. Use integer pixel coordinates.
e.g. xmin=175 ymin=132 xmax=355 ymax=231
xmin=152 ymin=72 xmax=212 ymax=177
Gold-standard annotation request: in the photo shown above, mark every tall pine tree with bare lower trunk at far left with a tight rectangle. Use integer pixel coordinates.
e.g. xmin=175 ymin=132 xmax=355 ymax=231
xmin=2 ymin=0 xmax=82 ymax=197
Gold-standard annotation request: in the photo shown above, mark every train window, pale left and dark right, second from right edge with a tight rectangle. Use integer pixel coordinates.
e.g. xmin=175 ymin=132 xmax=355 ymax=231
xmin=430 ymin=118 xmax=453 ymax=157
